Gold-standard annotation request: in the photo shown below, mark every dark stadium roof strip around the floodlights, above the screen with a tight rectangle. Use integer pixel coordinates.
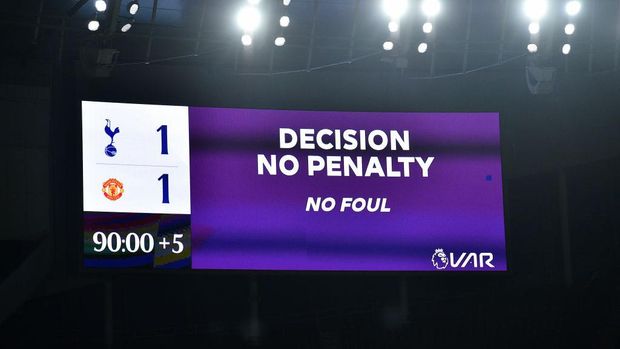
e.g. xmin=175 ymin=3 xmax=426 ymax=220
xmin=0 ymin=0 xmax=620 ymax=78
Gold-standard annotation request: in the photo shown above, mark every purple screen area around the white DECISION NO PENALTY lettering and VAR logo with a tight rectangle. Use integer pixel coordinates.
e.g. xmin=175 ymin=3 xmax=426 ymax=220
xmin=189 ymin=107 xmax=506 ymax=271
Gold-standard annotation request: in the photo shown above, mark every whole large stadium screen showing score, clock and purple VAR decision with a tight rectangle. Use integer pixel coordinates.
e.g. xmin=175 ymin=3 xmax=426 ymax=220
xmin=82 ymin=102 xmax=507 ymax=272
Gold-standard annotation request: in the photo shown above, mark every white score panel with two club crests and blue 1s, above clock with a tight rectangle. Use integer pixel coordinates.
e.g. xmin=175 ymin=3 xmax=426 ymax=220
xmin=82 ymin=101 xmax=191 ymax=214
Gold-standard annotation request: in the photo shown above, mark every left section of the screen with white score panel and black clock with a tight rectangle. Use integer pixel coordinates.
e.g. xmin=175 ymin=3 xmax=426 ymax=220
xmin=82 ymin=102 xmax=191 ymax=267
